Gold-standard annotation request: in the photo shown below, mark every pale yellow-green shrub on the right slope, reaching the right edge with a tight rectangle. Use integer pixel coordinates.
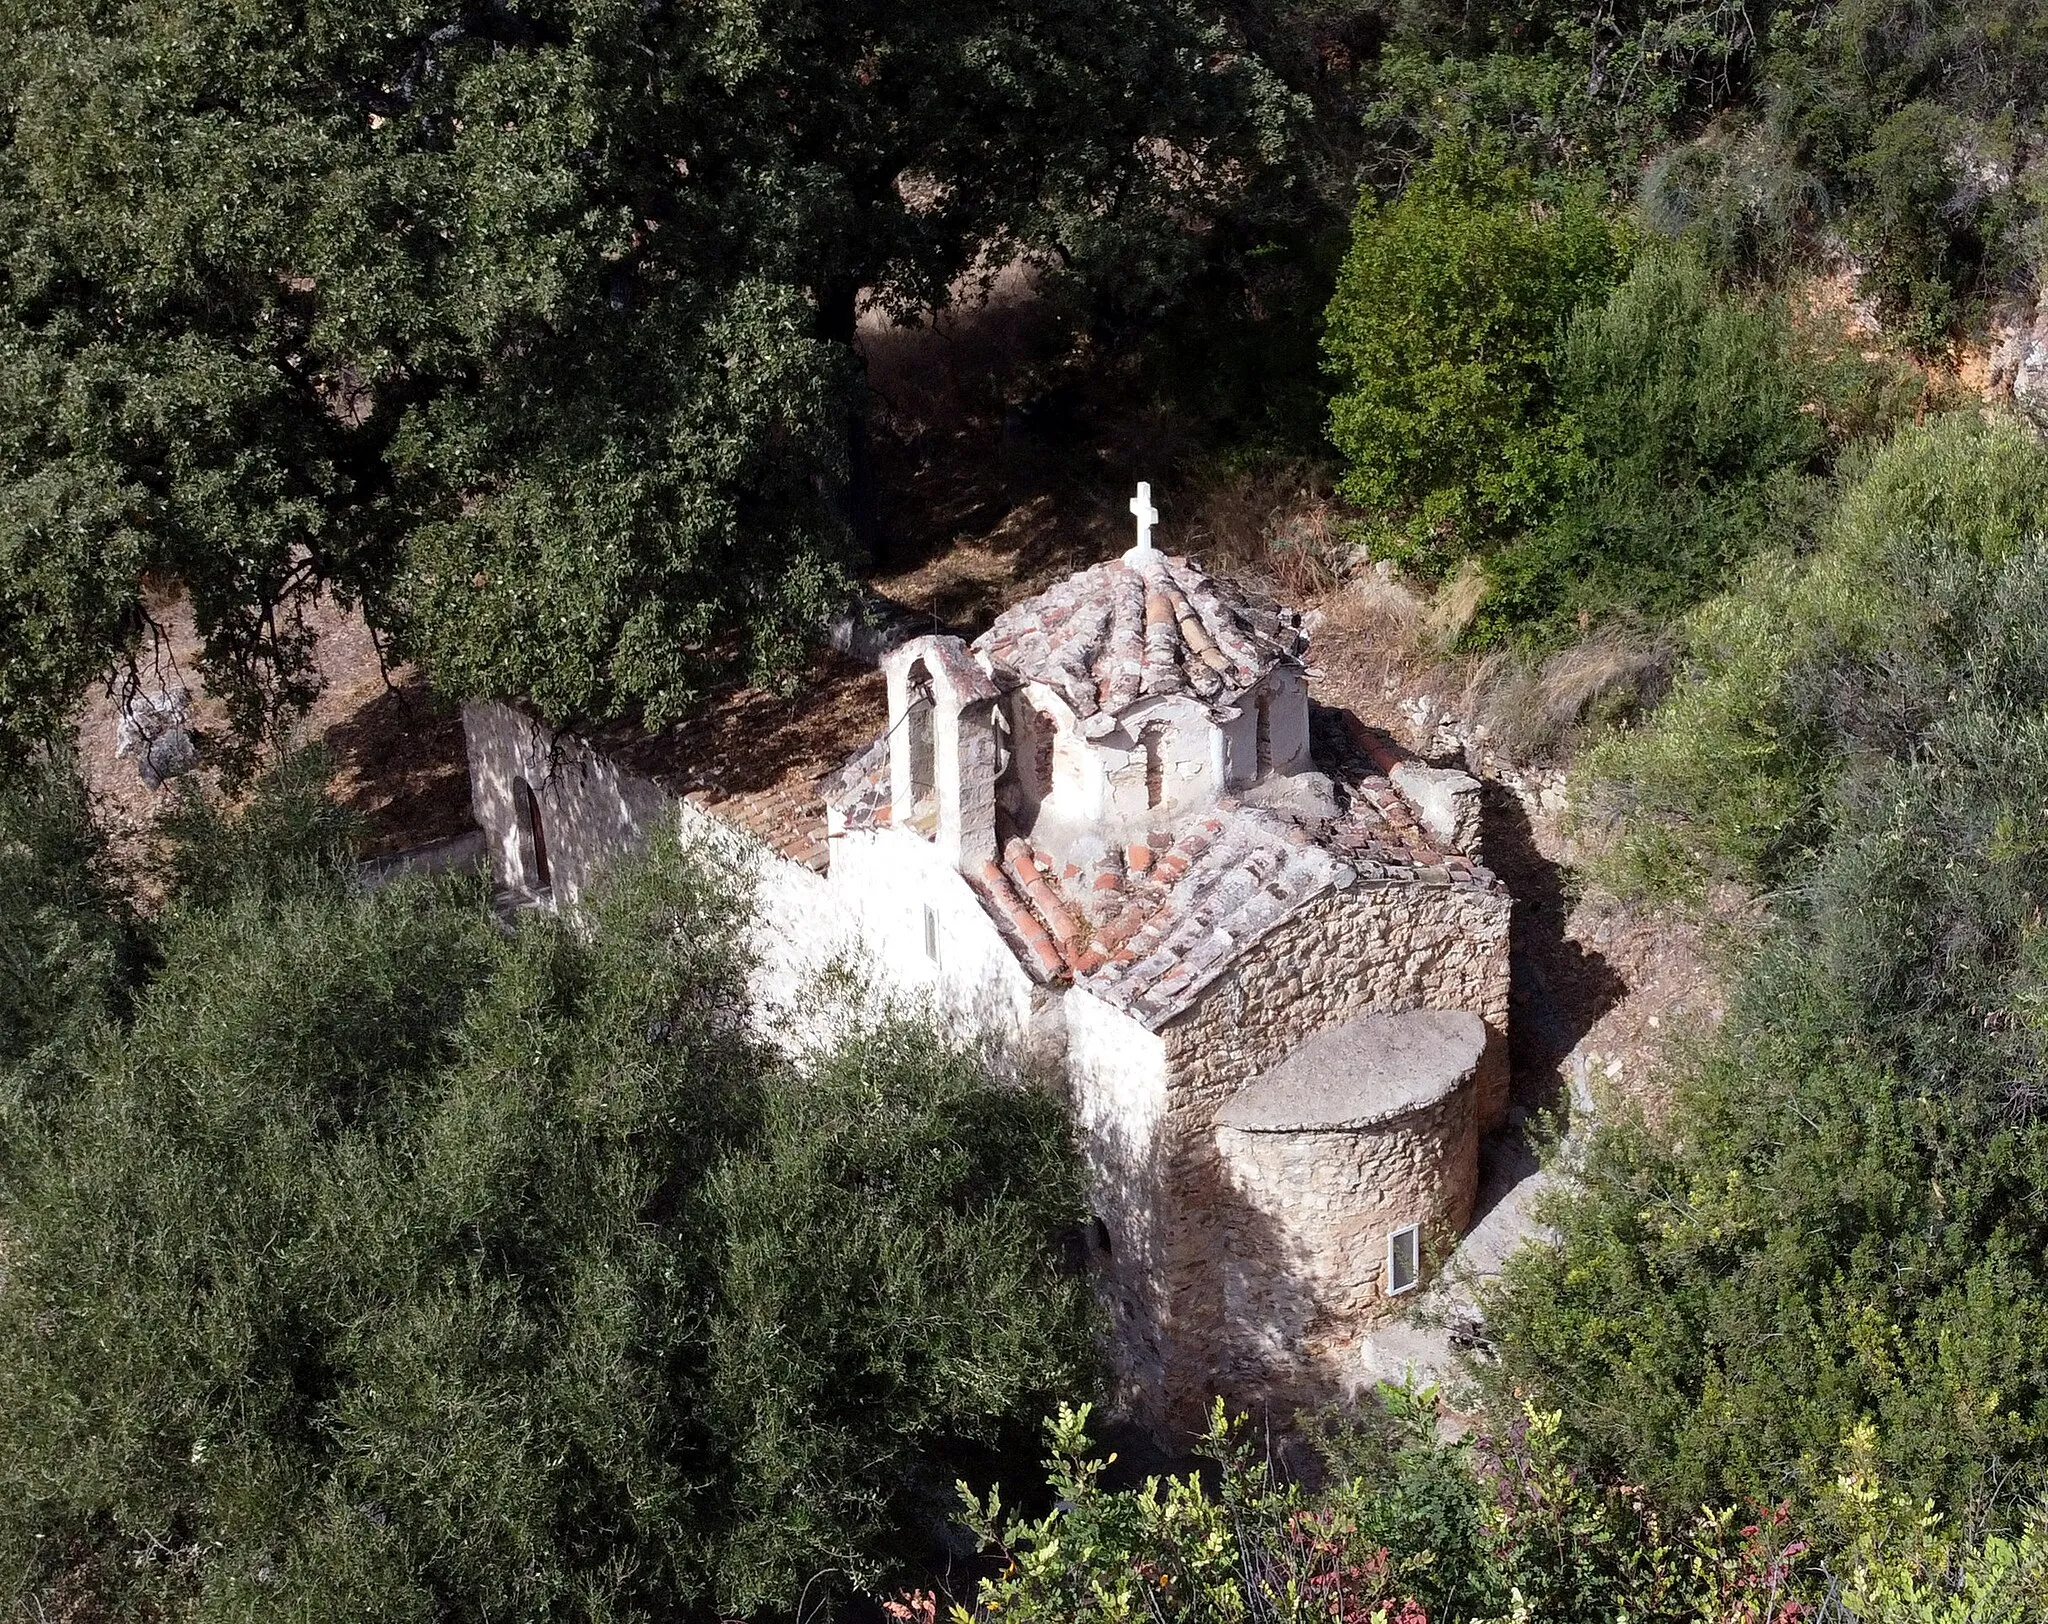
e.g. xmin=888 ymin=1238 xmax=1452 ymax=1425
xmin=1579 ymin=414 xmax=2048 ymax=895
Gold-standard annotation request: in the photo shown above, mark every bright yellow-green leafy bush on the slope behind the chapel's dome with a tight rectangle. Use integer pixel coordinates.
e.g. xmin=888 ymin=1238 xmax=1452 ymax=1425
xmin=1323 ymin=145 xmax=1624 ymax=573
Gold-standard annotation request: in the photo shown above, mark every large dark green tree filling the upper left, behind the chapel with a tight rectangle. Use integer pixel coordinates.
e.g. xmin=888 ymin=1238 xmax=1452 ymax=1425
xmin=0 ymin=0 xmax=1294 ymax=747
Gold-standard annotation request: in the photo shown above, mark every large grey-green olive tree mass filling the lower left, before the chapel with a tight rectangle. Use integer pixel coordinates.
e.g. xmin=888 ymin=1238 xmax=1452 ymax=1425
xmin=0 ymin=778 xmax=1090 ymax=1620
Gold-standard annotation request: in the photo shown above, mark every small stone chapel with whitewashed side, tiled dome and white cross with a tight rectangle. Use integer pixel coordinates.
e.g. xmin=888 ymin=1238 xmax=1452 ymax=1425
xmin=465 ymin=485 xmax=1509 ymax=1434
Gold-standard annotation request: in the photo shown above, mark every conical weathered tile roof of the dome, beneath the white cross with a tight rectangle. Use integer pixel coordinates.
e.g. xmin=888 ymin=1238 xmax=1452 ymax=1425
xmin=975 ymin=553 xmax=1309 ymax=733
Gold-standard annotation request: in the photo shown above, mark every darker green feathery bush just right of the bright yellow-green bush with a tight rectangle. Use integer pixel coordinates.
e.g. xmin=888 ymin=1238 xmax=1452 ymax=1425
xmin=1477 ymin=248 xmax=1825 ymax=639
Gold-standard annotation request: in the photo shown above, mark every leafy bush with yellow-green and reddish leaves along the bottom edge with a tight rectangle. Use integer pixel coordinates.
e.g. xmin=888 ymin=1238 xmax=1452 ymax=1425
xmin=937 ymin=1386 xmax=2048 ymax=1624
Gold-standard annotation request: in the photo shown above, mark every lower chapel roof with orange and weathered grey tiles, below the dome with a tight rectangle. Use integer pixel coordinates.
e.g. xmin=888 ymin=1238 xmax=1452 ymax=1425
xmin=946 ymin=713 xmax=1501 ymax=1028
